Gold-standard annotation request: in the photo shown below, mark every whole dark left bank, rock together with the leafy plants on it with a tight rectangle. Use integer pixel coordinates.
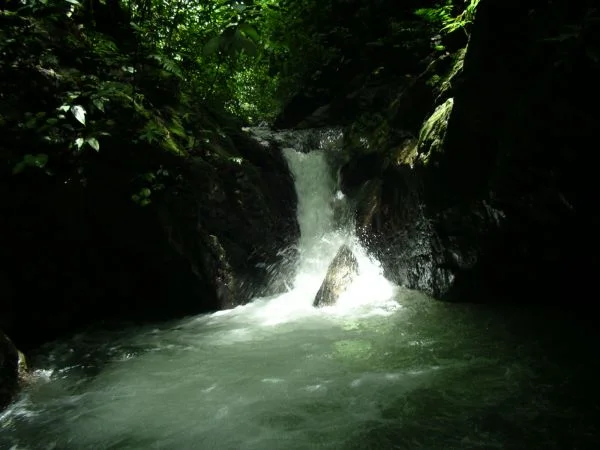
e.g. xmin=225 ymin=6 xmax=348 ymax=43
xmin=0 ymin=9 xmax=299 ymax=350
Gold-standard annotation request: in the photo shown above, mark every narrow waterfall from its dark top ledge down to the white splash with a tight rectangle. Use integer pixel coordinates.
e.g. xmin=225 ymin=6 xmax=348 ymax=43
xmin=244 ymin=128 xmax=398 ymax=321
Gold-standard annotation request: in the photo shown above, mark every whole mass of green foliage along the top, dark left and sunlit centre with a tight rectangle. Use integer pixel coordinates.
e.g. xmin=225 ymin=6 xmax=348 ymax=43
xmin=0 ymin=0 xmax=458 ymax=204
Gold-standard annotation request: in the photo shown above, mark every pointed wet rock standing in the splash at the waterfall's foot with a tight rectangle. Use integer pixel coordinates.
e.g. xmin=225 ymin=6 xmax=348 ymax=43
xmin=313 ymin=244 xmax=358 ymax=308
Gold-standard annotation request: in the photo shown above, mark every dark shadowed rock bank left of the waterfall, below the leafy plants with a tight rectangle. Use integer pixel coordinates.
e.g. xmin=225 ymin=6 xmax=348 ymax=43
xmin=0 ymin=126 xmax=299 ymax=350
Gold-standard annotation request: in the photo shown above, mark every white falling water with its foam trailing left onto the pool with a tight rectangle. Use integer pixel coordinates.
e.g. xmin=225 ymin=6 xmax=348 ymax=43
xmin=197 ymin=128 xmax=400 ymax=326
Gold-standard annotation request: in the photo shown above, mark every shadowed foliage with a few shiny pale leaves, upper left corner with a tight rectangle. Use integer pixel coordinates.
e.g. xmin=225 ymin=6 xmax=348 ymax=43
xmin=0 ymin=0 xmax=189 ymax=202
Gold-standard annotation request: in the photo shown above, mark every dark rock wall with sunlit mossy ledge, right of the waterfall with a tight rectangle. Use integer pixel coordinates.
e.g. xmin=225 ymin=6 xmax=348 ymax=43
xmin=284 ymin=0 xmax=600 ymax=302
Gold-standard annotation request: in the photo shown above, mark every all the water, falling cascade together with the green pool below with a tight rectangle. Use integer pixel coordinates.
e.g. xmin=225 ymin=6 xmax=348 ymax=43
xmin=0 ymin=128 xmax=597 ymax=450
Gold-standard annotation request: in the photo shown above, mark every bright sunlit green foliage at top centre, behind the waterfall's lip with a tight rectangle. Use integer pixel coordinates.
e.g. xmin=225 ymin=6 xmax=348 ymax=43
xmin=125 ymin=0 xmax=278 ymax=122
